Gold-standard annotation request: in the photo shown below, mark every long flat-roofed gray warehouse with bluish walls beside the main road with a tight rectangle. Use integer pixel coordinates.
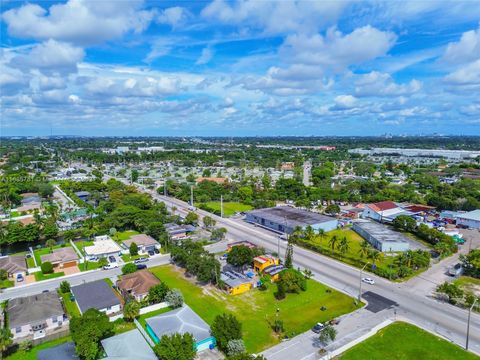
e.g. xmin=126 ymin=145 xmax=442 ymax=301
xmin=246 ymin=206 xmax=338 ymax=234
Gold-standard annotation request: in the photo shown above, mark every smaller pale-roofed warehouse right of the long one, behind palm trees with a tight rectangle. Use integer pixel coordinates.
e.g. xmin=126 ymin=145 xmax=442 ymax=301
xmin=352 ymin=220 xmax=410 ymax=252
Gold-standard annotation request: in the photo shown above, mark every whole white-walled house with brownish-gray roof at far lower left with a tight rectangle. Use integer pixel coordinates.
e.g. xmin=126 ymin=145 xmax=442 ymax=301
xmin=7 ymin=292 xmax=68 ymax=342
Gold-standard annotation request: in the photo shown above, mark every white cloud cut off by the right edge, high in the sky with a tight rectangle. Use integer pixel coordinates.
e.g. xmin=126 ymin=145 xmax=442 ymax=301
xmin=442 ymin=27 xmax=480 ymax=64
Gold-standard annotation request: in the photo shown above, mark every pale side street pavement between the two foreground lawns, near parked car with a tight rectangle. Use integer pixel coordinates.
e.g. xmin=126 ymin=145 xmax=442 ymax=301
xmin=262 ymin=308 xmax=394 ymax=360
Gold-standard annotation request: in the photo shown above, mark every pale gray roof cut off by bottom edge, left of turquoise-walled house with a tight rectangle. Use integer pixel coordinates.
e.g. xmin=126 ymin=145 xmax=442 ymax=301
xmin=101 ymin=329 xmax=157 ymax=360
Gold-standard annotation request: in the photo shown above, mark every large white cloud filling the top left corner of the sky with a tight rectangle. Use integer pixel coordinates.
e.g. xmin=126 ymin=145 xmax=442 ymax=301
xmin=2 ymin=0 xmax=154 ymax=45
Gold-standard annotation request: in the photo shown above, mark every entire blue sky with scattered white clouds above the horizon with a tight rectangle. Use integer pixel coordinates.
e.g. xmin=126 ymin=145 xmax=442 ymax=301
xmin=0 ymin=0 xmax=480 ymax=136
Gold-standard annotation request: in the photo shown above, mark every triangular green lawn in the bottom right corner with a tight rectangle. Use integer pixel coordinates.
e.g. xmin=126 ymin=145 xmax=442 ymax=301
xmin=340 ymin=322 xmax=478 ymax=360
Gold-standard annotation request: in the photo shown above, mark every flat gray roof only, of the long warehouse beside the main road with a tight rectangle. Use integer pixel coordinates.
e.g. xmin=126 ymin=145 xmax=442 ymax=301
xmin=248 ymin=206 xmax=335 ymax=227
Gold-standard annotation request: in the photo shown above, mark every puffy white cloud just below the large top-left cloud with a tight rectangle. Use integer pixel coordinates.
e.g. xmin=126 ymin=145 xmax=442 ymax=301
xmin=10 ymin=39 xmax=85 ymax=74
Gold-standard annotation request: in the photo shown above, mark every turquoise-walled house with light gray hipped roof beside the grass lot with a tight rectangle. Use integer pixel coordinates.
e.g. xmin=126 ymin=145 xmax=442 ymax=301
xmin=146 ymin=305 xmax=216 ymax=351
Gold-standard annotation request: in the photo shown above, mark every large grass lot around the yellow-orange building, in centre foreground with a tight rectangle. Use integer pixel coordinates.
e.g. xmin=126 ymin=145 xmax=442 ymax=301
xmin=150 ymin=265 xmax=357 ymax=353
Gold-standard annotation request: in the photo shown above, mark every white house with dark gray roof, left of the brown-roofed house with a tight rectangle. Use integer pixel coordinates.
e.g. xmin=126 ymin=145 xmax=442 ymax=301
xmin=71 ymin=279 xmax=121 ymax=315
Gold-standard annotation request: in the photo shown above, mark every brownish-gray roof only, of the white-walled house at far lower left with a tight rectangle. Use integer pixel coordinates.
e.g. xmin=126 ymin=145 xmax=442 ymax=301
xmin=7 ymin=292 xmax=65 ymax=328
